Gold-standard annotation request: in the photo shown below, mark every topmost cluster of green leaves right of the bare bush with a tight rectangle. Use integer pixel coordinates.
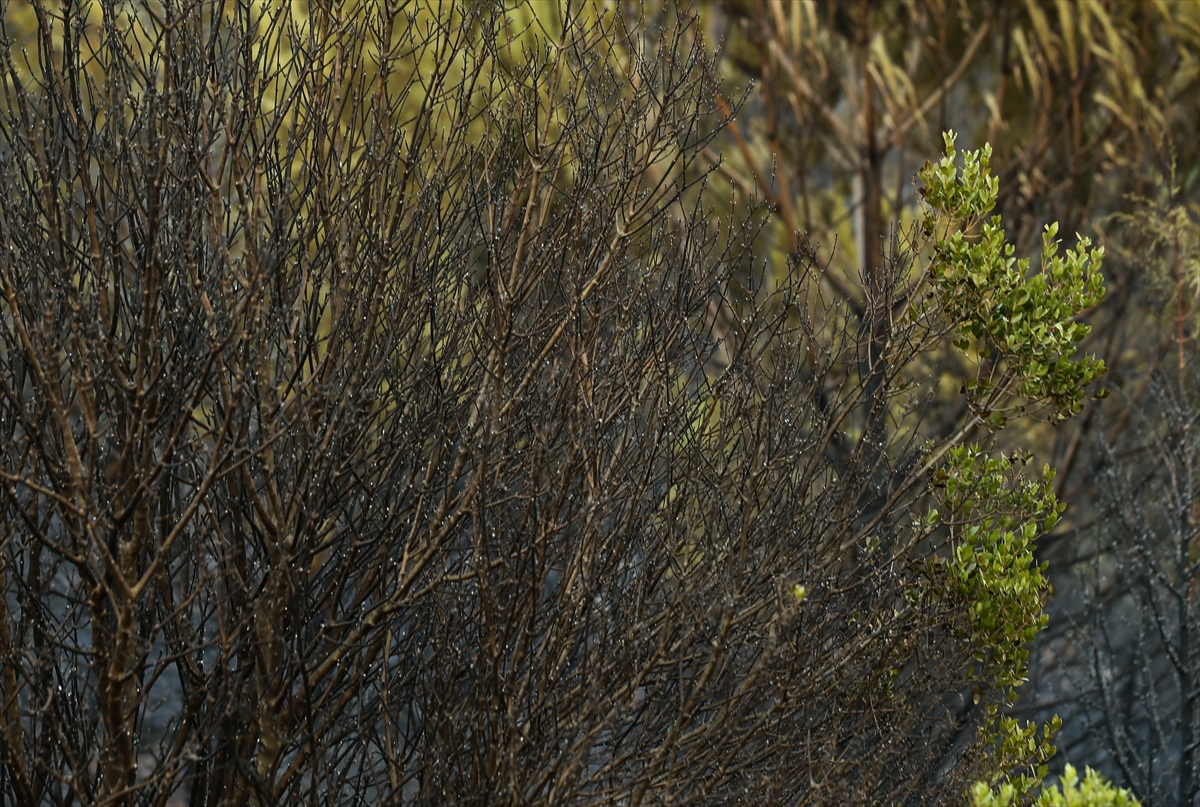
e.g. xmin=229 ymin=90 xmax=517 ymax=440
xmin=920 ymin=132 xmax=1105 ymax=426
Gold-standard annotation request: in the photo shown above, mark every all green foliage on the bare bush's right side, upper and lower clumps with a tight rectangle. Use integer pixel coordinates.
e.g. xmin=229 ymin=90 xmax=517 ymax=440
xmin=914 ymin=132 xmax=1105 ymax=803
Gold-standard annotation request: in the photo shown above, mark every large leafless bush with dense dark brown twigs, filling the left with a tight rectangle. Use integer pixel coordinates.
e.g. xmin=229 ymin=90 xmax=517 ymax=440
xmin=0 ymin=2 xmax=1094 ymax=805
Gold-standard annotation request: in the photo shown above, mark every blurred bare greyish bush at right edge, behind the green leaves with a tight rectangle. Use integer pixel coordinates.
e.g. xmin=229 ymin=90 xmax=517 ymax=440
xmin=1039 ymin=371 xmax=1200 ymax=806
